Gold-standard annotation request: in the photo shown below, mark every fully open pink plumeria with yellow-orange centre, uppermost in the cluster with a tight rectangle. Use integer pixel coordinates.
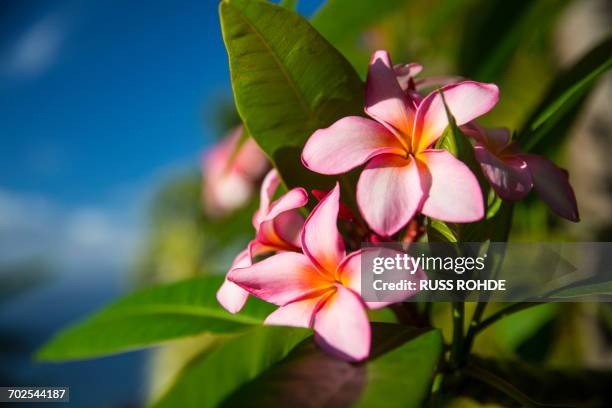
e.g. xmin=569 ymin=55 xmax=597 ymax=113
xmin=302 ymin=51 xmax=499 ymax=236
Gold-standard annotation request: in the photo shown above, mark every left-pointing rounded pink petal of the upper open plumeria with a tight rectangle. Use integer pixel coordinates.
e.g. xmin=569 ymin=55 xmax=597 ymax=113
xmin=302 ymin=116 xmax=404 ymax=174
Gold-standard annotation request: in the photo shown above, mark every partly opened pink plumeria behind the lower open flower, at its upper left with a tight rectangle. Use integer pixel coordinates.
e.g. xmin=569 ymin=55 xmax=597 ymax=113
xmin=217 ymin=169 xmax=308 ymax=313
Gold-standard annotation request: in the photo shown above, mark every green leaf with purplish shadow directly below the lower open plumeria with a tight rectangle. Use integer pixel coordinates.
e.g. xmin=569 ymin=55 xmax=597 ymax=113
xmin=223 ymin=323 xmax=442 ymax=407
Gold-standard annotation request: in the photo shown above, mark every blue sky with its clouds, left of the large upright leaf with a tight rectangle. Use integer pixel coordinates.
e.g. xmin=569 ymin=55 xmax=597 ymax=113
xmin=0 ymin=0 xmax=321 ymax=272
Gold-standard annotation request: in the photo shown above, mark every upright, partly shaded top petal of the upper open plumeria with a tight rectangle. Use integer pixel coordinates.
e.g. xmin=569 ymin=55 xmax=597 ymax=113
xmin=365 ymin=51 xmax=415 ymax=137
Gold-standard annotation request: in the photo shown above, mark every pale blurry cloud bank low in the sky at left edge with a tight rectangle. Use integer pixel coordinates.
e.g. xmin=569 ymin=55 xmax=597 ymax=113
xmin=0 ymin=190 xmax=141 ymax=274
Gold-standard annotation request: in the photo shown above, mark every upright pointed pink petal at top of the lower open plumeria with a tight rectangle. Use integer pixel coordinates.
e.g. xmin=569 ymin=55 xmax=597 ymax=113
xmin=302 ymin=183 xmax=344 ymax=278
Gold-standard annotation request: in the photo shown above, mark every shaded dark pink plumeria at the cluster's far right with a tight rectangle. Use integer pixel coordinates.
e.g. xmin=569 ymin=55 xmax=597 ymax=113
xmin=464 ymin=123 xmax=580 ymax=222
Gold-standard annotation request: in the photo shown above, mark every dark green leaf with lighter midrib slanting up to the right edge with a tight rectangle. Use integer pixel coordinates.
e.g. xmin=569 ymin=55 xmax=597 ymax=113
xmin=517 ymin=36 xmax=612 ymax=152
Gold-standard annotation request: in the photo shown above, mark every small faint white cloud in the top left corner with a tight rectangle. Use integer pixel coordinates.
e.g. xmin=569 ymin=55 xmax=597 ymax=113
xmin=0 ymin=14 xmax=67 ymax=78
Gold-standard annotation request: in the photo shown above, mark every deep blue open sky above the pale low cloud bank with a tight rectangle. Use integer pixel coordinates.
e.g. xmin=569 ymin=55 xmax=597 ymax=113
xmin=0 ymin=1 xmax=234 ymax=205
